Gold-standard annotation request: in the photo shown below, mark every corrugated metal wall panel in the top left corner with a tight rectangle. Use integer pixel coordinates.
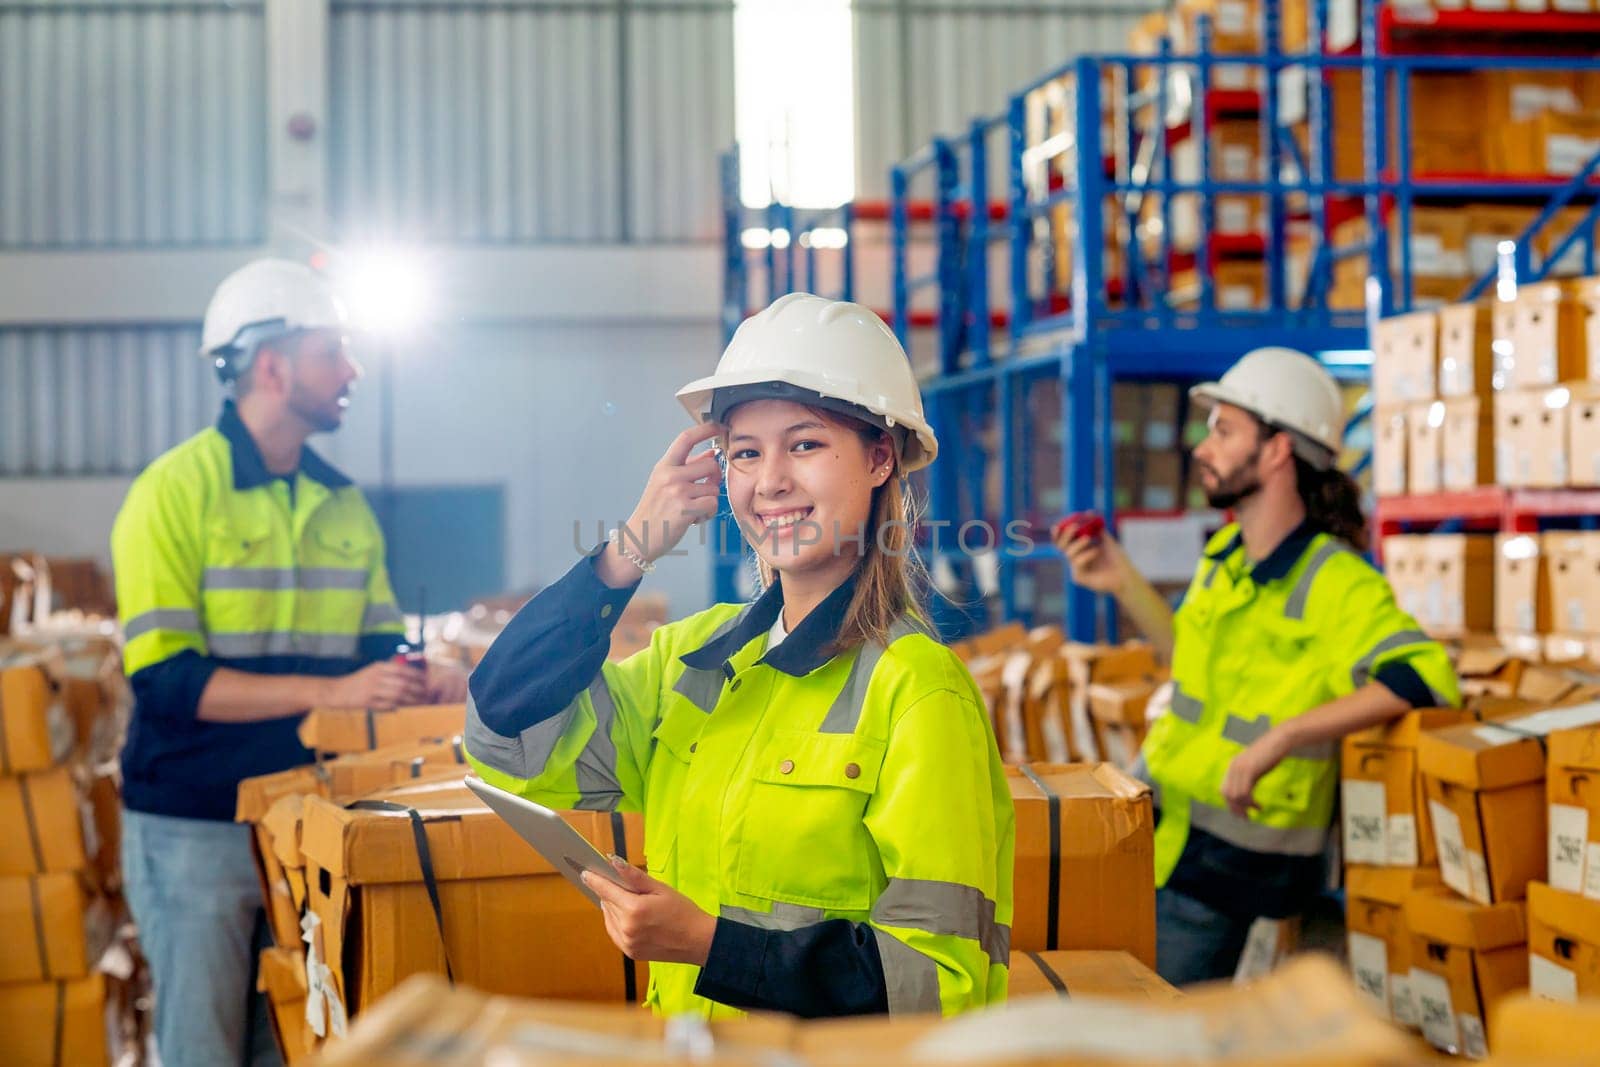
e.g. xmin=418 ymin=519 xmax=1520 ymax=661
xmin=0 ymin=0 xmax=266 ymax=251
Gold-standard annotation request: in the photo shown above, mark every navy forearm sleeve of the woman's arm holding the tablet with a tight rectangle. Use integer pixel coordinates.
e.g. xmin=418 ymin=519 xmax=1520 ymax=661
xmin=694 ymin=918 xmax=890 ymax=1019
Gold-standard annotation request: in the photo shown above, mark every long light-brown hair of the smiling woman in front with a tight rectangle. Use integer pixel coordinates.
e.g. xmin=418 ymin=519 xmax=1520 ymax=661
xmin=755 ymin=406 xmax=931 ymax=654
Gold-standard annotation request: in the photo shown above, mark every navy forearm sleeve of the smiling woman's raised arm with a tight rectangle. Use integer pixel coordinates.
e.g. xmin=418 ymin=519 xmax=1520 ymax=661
xmin=467 ymin=553 xmax=638 ymax=737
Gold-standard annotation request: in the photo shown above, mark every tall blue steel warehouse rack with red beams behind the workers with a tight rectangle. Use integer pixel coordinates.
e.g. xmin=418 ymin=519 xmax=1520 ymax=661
xmin=717 ymin=0 xmax=1600 ymax=640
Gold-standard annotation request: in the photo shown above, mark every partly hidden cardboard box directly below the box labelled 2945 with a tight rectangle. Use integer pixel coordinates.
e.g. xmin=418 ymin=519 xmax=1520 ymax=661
xmin=1344 ymin=865 xmax=1438 ymax=1029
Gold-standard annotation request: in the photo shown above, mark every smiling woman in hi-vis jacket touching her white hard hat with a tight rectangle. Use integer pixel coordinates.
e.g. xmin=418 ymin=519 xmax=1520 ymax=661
xmin=466 ymin=293 xmax=1014 ymax=1016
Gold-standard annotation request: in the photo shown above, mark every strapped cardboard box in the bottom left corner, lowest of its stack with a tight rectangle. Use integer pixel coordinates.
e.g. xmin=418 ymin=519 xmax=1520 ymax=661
xmin=0 ymin=974 xmax=106 ymax=1067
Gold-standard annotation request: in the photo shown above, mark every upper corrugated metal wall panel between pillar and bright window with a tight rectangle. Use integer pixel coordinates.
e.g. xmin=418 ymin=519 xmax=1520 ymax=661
xmin=330 ymin=0 xmax=733 ymax=243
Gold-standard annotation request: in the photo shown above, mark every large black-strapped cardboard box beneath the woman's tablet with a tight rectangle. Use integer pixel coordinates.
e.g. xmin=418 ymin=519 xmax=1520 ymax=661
xmin=301 ymin=781 xmax=645 ymax=1027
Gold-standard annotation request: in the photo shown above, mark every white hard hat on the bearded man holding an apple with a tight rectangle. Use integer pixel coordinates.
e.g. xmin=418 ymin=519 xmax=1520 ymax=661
xmin=1189 ymin=347 xmax=1344 ymax=470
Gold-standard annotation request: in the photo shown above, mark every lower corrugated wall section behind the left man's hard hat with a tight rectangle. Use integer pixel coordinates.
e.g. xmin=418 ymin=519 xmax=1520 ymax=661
xmin=0 ymin=326 xmax=221 ymax=475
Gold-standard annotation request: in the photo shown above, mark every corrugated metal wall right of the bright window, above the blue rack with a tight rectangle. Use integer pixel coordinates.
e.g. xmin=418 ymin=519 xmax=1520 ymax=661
xmin=856 ymin=0 xmax=1165 ymax=198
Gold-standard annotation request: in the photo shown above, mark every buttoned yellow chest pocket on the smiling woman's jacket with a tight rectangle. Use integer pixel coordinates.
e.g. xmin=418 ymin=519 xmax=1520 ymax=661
xmin=734 ymin=729 xmax=885 ymax=910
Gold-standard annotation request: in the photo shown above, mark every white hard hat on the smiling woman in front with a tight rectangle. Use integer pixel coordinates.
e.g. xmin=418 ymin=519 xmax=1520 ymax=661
xmin=678 ymin=293 xmax=939 ymax=474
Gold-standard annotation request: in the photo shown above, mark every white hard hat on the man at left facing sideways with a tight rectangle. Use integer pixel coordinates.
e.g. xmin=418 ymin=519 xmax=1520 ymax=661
xmin=200 ymin=259 xmax=346 ymax=357
